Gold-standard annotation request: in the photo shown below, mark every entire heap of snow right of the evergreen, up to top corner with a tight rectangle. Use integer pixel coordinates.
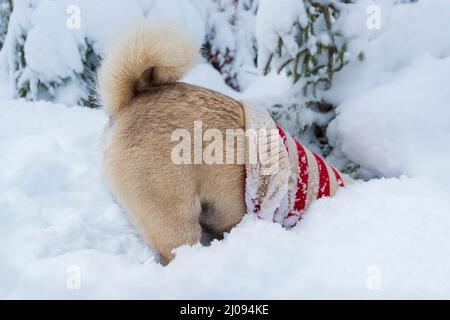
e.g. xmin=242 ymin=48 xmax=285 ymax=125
xmin=327 ymin=0 xmax=450 ymax=177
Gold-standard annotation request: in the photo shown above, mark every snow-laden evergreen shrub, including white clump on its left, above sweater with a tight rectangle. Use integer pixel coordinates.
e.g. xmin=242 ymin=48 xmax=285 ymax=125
xmin=256 ymin=0 xmax=358 ymax=168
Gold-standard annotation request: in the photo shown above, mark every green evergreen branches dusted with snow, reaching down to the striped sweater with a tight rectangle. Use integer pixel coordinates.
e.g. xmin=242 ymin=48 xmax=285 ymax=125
xmin=263 ymin=0 xmax=365 ymax=174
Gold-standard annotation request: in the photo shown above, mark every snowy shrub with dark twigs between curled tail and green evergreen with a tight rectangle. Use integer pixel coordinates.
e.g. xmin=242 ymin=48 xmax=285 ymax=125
xmin=203 ymin=0 xmax=259 ymax=90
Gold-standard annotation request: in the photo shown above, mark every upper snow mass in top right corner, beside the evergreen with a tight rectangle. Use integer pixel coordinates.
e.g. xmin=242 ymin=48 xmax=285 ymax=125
xmin=329 ymin=0 xmax=450 ymax=103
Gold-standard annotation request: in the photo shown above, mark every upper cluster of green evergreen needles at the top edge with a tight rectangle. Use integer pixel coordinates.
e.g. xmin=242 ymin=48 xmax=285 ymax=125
xmin=264 ymin=0 xmax=356 ymax=101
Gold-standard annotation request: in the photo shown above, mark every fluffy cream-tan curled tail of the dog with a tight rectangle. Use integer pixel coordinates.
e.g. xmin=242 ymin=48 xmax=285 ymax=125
xmin=97 ymin=21 xmax=198 ymax=115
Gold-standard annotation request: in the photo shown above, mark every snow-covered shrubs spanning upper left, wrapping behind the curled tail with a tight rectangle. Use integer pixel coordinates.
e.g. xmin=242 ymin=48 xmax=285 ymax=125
xmin=0 ymin=0 xmax=205 ymax=107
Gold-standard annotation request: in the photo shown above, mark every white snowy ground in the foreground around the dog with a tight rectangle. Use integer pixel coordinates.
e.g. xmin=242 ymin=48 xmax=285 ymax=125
xmin=0 ymin=100 xmax=450 ymax=298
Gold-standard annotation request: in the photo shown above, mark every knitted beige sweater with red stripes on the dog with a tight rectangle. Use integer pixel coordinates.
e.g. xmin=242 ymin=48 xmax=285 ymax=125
xmin=242 ymin=102 xmax=351 ymax=229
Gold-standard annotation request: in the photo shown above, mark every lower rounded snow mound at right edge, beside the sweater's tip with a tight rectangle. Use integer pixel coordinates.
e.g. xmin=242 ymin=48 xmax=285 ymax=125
xmin=328 ymin=57 xmax=450 ymax=177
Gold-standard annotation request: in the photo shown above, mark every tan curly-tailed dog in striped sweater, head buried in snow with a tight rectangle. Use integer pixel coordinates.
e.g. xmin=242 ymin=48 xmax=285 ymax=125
xmin=98 ymin=22 xmax=350 ymax=264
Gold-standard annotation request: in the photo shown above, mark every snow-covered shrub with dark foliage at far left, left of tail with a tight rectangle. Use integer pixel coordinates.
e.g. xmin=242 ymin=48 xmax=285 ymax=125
xmin=2 ymin=0 xmax=99 ymax=106
